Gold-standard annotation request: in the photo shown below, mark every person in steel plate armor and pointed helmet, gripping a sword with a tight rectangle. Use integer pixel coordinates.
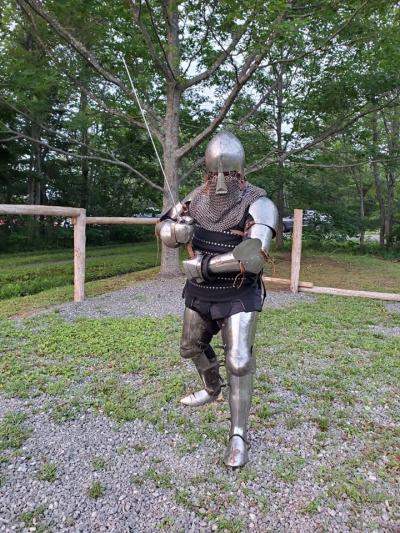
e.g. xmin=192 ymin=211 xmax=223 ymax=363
xmin=156 ymin=132 xmax=277 ymax=467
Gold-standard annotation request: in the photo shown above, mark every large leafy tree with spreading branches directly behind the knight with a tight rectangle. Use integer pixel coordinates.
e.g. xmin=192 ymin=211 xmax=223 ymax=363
xmin=1 ymin=0 xmax=398 ymax=264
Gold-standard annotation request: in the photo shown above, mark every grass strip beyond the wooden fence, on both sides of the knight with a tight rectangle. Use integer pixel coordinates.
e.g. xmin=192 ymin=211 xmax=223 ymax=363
xmin=0 ymin=241 xmax=400 ymax=317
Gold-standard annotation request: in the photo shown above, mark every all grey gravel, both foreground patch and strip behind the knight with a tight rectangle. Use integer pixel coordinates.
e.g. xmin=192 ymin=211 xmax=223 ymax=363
xmin=0 ymin=280 xmax=400 ymax=533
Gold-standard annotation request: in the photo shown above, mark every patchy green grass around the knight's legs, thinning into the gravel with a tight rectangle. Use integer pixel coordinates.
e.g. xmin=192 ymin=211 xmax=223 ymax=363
xmin=0 ymin=251 xmax=400 ymax=531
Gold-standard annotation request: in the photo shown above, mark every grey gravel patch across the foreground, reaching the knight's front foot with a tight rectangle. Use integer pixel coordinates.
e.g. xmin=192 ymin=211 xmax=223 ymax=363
xmin=0 ymin=389 xmax=398 ymax=533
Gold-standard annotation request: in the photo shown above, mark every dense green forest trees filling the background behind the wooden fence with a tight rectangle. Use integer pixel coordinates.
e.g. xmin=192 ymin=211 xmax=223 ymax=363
xmin=0 ymin=0 xmax=400 ymax=268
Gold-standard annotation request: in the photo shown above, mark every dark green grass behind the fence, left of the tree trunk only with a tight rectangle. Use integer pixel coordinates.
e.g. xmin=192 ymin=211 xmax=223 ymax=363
xmin=0 ymin=240 xmax=159 ymax=300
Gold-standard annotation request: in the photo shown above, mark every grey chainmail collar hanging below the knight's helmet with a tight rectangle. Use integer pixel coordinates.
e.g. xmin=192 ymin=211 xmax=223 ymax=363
xmin=189 ymin=173 xmax=266 ymax=231
